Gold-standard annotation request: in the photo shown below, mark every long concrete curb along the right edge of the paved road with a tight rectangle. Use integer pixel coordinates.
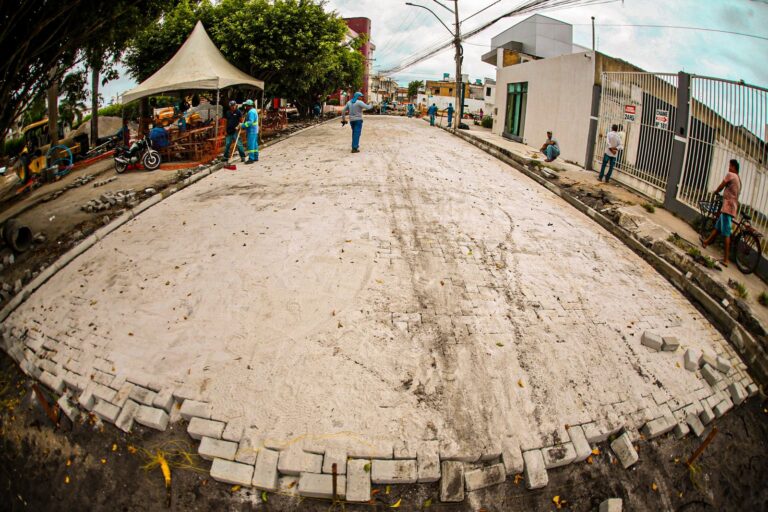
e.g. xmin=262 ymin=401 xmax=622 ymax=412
xmin=443 ymin=128 xmax=768 ymax=387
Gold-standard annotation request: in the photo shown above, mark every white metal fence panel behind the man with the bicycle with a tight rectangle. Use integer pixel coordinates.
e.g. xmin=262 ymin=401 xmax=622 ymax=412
xmin=677 ymin=76 xmax=768 ymax=238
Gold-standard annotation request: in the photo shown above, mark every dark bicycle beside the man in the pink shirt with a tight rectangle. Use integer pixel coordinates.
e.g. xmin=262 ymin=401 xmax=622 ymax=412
xmin=699 ymin=194 xmax=763 ymax=274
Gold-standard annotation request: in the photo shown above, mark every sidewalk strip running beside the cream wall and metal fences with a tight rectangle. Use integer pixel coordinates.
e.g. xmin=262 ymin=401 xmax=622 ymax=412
xmin=448 ymin=126 xmax=768 ymax=348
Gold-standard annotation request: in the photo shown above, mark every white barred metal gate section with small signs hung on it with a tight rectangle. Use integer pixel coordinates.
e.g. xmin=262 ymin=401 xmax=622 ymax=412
xmin=594 ymin=72 xmax=678 ymax=193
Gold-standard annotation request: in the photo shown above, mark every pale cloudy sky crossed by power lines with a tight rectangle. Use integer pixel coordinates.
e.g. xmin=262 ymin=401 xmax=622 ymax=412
xmin=103 ymin=0 xmax=768 ymax=100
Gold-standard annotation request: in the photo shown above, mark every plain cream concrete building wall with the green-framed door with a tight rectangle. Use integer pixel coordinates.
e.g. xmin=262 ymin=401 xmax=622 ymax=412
xmin=493 ymin=52 xmax=595 ymax=166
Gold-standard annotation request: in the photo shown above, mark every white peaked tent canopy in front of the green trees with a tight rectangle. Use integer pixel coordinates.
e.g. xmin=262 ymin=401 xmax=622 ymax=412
xmin=123 ymin=21 xmax=264 ymax=103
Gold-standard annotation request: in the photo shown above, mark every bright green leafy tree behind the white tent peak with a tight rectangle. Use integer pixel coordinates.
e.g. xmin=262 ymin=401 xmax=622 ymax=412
xmin=125 ymin=0 xmax=364 ymax=116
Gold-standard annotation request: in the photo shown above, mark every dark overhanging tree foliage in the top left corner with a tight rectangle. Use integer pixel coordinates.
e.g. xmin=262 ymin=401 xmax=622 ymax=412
xmin=0 ymin=0 xmax=176 ymax=148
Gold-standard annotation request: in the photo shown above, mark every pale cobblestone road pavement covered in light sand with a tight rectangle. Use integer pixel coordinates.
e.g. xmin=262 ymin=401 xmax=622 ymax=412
xmin=6 ymin=118 xmax=751 ymax=494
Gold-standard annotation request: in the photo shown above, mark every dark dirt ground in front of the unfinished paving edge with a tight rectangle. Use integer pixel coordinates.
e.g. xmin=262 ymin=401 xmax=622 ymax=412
xmin=0 ymin=348 xmax=768 ymax=512
